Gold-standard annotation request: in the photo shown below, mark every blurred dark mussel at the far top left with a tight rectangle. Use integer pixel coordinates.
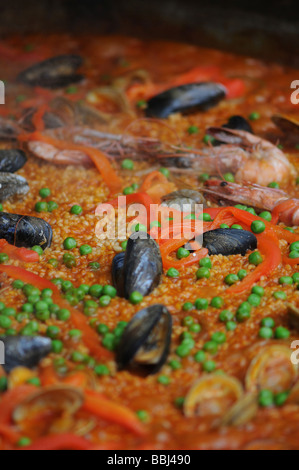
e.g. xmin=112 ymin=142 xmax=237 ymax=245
xmin=17 ymin=54 xmax=83 ymax=89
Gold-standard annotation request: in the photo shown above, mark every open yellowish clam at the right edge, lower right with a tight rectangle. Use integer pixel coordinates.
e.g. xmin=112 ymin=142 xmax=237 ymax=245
xmin=245 ymin=344 xmax=298 ymax=393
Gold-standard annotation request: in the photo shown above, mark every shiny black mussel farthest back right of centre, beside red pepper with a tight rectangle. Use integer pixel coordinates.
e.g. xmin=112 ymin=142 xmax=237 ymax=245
xmin=146 ymin=82 xmax=226 ymax=119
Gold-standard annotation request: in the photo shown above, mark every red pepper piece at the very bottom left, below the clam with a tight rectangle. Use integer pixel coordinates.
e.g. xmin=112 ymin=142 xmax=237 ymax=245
xmin=21 ymin=434 xmax=94 ymax=450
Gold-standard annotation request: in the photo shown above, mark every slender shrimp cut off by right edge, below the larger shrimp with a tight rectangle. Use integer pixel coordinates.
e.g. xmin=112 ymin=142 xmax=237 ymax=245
xmin=205 ymin=179 xmax=299 ymax=226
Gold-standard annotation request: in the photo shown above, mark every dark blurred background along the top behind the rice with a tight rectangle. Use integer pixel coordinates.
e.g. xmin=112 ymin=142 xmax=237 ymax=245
xmin=0 ymin=0 xmax=299 ymax=68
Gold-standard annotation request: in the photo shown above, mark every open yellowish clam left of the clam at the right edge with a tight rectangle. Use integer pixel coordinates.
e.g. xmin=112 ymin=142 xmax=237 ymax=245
xmin=184 ymin=374 xmax=243 ymax=418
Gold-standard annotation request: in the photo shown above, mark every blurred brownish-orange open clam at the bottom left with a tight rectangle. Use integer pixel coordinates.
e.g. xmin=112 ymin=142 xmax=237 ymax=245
xmin=13 ymin=385 xmax=84 ymax=432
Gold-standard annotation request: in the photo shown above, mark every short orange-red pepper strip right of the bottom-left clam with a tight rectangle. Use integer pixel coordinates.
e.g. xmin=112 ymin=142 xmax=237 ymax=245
xmin=82 ymin=390 xmax=147 ymax=436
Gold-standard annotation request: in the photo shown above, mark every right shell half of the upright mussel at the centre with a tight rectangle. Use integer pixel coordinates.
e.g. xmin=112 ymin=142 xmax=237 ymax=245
xmin=124 ymin=232 xmax=163 ymax=299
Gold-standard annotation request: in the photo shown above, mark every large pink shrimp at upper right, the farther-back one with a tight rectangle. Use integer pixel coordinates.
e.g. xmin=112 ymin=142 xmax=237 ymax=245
xmin=164 ymin=127 xmax=294 ymax=186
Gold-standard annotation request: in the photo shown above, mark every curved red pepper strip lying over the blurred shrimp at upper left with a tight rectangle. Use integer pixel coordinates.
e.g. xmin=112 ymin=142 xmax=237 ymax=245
xmin=19 ymin=132 xmax=122 ymax=194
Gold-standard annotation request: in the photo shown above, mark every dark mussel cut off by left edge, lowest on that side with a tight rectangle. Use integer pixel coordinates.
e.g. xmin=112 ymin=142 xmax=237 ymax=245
xmin=0 ymin=336 xmax=52 ymax=373
